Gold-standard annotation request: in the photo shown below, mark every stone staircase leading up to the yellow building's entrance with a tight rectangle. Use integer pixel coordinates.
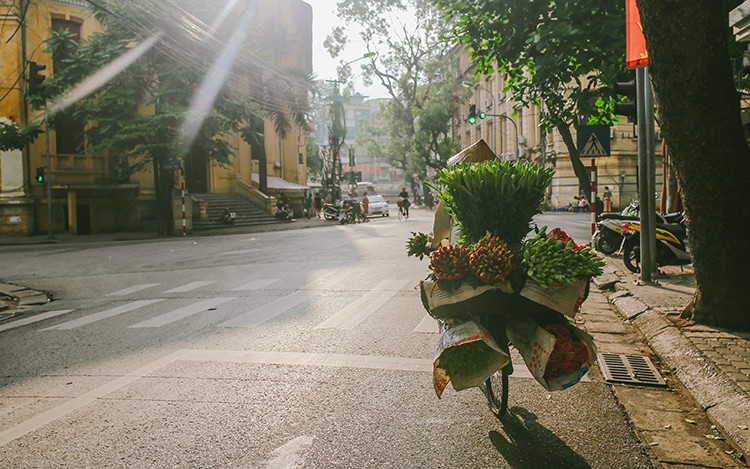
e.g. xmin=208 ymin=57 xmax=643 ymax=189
xmin=192 ymin=192 xmax=290 ymax=231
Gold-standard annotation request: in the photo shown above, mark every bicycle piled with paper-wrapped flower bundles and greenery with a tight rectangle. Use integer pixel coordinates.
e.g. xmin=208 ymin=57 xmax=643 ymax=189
xmin=407 ymin=140 xmax=604 ymax=417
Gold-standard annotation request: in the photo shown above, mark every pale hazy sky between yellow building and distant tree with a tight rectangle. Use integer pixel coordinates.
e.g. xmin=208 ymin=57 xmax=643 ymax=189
xmin=305 ymin=0 xmax=387 ymax=98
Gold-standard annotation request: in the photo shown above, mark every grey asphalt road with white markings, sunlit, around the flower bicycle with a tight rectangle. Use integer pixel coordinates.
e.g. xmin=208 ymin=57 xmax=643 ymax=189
xmin=0 ymin=210 xmax=651 ymax=468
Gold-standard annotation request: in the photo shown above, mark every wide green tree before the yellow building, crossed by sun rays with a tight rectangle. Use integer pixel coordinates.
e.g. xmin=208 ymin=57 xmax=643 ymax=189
xmin=45 ymin=1 xmax=310 ymax=234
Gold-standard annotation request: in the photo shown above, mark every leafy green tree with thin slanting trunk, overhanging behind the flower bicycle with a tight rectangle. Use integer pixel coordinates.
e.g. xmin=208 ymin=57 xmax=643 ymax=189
xmin=433 ymin=0 xmax=625 ymax=191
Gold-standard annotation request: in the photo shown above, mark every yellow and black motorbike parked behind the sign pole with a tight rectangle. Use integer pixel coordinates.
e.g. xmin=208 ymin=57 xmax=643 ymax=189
xmin=622 ymin=213 xmax=692 ymax=274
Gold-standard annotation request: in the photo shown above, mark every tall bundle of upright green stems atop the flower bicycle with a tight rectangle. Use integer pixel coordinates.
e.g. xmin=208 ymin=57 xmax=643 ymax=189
xmin=438 ymin=160 xmax=554 ymax=246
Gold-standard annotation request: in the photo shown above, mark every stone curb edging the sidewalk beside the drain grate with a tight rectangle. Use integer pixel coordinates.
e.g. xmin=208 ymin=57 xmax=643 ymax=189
xmin=609 ymin=283 xmax=750 ymax=461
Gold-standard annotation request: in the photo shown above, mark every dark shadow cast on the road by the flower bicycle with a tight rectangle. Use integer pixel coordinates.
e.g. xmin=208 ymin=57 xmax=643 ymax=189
xmin=489 ymin=407 xmax=591 ymax=469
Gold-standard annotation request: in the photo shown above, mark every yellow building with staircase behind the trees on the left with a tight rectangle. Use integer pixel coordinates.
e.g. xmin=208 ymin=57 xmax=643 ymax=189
xmin=0 ymin=0 xmax=312 ymax=236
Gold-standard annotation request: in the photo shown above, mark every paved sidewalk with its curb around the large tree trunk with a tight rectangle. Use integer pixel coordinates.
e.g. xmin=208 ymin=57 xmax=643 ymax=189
xmin=595 ymin=257 xmax=750 ymax=461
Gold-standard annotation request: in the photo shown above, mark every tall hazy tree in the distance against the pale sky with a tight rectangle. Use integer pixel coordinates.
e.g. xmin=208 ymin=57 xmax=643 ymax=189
xmin=326 ymin=0 xmax=459 ymax=176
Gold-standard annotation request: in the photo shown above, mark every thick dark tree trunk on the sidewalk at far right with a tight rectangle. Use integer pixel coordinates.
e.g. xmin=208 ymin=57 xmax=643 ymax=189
xmin=638 ymin=0 xmax=750 ymax=330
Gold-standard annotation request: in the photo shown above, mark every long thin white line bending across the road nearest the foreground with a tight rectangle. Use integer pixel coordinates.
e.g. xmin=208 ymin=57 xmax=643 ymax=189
xmin=0 ymin=350 xmax=560 ymax=446
